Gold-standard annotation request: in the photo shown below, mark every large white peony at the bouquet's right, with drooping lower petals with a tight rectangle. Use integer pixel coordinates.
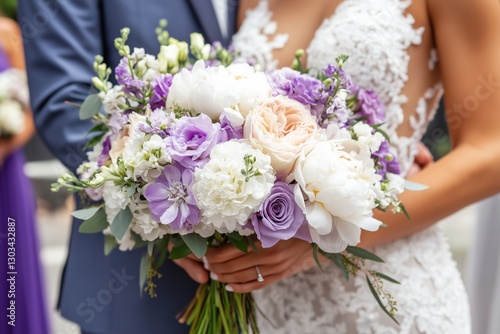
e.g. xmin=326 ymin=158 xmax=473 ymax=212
xmin=294 ymin=140 xmax=381 ymax=253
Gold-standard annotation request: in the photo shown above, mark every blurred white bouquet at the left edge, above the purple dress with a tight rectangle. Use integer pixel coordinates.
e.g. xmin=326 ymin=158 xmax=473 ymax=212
xmin=0 ymin=69 xmax=29 ymax=137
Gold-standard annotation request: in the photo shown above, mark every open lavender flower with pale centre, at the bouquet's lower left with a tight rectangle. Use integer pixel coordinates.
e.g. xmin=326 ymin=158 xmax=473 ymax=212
xmin=144 ymin=165 xmax=200 ymax=231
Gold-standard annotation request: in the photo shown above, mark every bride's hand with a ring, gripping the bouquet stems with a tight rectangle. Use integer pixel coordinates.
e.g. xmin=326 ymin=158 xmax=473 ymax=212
xmin=204 ymin=238 xmax=317 ymax=293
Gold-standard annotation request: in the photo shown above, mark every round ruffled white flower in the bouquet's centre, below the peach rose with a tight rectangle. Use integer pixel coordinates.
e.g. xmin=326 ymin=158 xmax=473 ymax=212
xmin=192 ymin=140 xmax=276 ymax=232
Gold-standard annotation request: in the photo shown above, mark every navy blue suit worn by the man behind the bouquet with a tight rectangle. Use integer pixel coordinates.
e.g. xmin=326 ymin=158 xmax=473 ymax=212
xmin=18 ymin=0 xmax=237 ymax=334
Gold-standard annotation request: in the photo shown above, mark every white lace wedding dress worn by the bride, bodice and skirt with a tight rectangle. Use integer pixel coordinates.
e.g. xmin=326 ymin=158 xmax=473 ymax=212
xmin=234 ymin=0 xmax=470 ymax=334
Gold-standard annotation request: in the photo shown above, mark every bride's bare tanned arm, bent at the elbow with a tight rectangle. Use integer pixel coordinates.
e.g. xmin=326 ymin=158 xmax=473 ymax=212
xmin=361 ymin=0 xmax=500 ymax=247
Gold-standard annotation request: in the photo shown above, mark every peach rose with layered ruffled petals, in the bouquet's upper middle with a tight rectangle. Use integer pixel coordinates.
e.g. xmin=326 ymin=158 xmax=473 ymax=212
xmin=244 ymin=95 xmax=318 ymax=180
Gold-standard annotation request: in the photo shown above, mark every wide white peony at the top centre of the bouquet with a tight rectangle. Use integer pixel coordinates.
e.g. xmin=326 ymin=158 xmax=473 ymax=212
xmin=167 ymin=60 xmax=272 ymax=121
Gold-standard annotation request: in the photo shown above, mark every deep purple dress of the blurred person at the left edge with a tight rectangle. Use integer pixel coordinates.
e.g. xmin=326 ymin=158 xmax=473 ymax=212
xmin=0 ymin=49 xmax=49 ymax=334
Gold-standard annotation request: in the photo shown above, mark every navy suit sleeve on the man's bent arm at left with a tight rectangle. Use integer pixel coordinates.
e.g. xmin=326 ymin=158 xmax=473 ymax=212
xmin=18 ymin=0 xmax=103 ymax=171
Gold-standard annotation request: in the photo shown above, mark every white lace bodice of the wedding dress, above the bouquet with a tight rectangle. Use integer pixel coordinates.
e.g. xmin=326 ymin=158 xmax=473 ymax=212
xmin=233 ymin=0 xmax=441 ymax=175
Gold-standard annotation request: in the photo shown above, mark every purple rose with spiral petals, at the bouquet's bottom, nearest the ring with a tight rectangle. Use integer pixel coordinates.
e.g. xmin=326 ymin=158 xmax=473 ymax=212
xmin=251 ymin=181 xmax=311 ymax=248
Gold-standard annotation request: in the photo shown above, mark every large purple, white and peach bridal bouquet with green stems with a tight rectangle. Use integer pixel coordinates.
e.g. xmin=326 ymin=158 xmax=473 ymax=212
xmin=54 ymin=25 xmax=404 ymax=333
